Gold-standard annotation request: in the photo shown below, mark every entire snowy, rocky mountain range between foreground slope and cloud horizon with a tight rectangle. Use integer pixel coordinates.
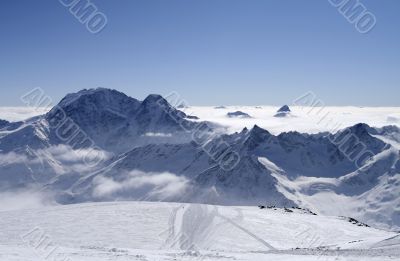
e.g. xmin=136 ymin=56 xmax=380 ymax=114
xmin=0 ymin=88 xmax=400 ymax=230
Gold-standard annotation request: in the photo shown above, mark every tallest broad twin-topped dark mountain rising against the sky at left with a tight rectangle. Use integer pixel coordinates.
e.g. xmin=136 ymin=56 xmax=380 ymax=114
xmin=0 ymin=88 xmax=196 ymax=153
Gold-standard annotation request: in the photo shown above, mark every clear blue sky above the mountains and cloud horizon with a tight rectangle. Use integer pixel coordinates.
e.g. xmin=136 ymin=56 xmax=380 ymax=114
xmin=0 ymin=0 xmax=400 ymax=106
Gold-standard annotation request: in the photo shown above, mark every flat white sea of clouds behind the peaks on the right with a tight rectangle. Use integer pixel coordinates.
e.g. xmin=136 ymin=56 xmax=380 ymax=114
xmin=182 ymin=104 xmax=400 ymax=134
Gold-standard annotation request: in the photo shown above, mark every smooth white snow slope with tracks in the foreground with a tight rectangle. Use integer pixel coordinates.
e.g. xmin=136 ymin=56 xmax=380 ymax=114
xmin=0 ymin=202 xmax=400 ymax=261
